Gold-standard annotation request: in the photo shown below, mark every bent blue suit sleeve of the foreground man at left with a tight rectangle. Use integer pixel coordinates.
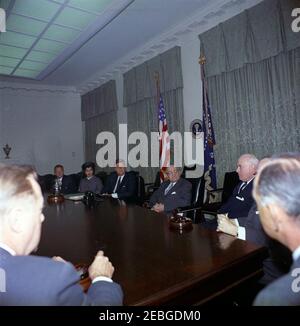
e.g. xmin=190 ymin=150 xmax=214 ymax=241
xmin=56 ymin=263 xmax=123 ymax=306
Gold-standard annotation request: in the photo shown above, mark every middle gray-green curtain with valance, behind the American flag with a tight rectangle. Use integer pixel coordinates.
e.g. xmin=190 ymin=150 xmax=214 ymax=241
xmin=123 ymin=47 xmax=184 ymax=182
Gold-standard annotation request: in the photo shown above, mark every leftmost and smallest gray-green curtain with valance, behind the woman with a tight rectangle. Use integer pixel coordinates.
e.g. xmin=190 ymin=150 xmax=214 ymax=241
xmin=81 ymin=80 xmax=118 ymax=172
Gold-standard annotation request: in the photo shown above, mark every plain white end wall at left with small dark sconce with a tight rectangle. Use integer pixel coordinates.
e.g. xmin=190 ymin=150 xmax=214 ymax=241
xmin=0 ymin=87 xmax=83 ymax=174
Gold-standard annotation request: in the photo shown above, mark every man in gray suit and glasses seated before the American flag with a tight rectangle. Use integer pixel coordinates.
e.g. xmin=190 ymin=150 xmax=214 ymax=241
xmin=149 ymin=165 xmax=192 ymax=215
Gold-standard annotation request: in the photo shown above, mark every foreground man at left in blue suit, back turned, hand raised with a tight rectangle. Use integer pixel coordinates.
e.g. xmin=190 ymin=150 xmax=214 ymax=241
xmin=0 ymin=165 xmax=123 ymax=306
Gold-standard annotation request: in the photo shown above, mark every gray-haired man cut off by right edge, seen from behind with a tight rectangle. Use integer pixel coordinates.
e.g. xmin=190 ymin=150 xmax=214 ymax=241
xmin=253 ymin=157 xmax=300 ymax=306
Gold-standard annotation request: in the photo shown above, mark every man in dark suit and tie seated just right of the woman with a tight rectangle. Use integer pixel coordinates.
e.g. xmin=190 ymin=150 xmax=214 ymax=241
xmin=102 ymin=159 xmax=137 ymax=200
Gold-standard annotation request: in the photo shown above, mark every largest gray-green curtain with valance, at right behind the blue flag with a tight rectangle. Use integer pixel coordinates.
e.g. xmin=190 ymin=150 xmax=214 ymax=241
xmin=199 ymin=0 xmax=300 ymax=185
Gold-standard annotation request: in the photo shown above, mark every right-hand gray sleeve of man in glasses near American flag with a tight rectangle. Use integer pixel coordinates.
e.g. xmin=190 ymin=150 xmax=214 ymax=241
xmin=164 ymin=180 xmax=192 ymax=212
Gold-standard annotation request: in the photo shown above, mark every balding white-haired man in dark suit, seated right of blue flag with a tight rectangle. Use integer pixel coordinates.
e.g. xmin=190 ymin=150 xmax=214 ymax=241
xmin=218 ymin=154 xmax=259 ymax=223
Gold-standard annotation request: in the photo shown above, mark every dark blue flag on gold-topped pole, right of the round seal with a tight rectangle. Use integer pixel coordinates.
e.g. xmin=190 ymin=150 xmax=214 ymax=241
xmin=201 ymin=64 xmax=217 ymax=190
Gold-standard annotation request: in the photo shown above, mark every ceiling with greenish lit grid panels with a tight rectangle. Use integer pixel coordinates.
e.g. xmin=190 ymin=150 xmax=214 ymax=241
xmin=0 ymin=0 xmax=262 ymax=87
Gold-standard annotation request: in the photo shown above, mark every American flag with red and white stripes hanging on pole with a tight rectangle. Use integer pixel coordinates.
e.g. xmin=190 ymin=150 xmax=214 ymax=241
xmin=158 ymin=94 xmax=170 ymax=182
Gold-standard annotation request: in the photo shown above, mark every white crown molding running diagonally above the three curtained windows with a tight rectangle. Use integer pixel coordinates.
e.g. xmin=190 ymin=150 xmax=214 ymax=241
xmin=76 ymin=0 xmax=263 ymax=94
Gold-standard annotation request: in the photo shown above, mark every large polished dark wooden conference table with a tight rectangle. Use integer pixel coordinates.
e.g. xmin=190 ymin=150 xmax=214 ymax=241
xmin=37 ymin=199 xmax=265 ymax=305
